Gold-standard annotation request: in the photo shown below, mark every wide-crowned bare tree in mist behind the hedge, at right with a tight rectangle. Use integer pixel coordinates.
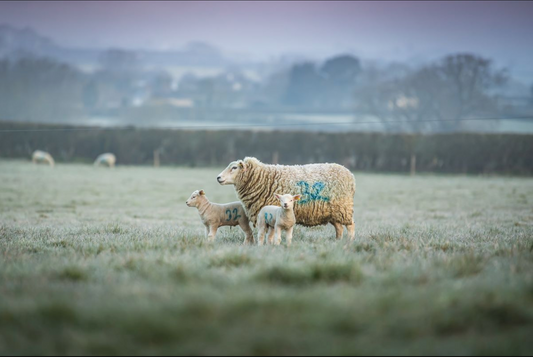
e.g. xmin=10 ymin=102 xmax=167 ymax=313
xmin=358 ymin=54 xmax=507 ymax=131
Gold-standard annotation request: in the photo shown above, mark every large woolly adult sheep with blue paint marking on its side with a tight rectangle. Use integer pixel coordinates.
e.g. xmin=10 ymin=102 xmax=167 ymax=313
xmin=217 ymin=157 xmax=355 ymax=240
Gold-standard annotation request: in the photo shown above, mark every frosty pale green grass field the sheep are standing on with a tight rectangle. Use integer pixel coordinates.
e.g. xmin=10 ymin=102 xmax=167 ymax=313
xmin=0 ymin=161 xmax=533 ymax=355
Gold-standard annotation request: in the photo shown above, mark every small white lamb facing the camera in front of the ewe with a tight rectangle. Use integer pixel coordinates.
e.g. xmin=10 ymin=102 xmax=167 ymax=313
xmin=257 ymin=194 xmax=301 ymax=247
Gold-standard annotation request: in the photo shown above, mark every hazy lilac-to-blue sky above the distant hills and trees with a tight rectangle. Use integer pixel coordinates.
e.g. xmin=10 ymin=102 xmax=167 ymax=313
xmin=0 ymin=1 xmax=533 ymax=75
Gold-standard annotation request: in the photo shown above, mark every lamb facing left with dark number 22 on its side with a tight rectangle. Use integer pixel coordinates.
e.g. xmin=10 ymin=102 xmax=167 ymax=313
xmin=186 ymin=190 xmax=254 ymax=244
